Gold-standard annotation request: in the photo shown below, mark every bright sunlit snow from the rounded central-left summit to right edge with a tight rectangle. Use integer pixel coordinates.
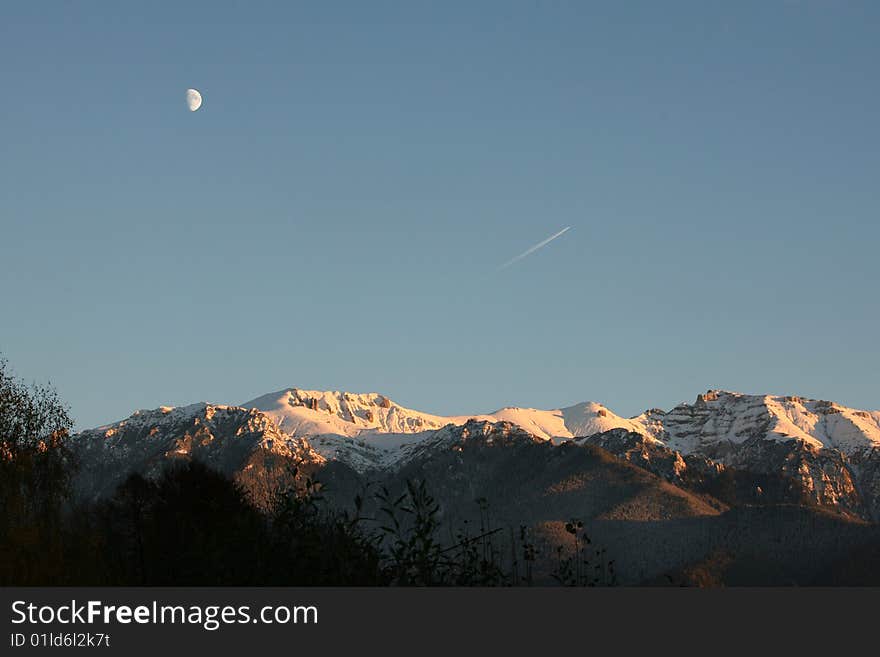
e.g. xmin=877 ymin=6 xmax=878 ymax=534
xmin=245 ymin=388 xmax=880 ymax=462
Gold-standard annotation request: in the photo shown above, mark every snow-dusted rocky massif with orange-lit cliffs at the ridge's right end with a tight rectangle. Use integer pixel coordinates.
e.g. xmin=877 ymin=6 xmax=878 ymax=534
xmin=600 ymin=391 xmax=880 ymax=520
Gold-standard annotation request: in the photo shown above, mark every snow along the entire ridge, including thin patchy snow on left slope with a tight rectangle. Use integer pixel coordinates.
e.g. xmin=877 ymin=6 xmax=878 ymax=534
xmin=79 ymin=388 xmax=880 ymax=471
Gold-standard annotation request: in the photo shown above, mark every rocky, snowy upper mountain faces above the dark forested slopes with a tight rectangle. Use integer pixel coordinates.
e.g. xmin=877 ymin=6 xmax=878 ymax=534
xmin=74 ymin=388 xmax=880 ymax=520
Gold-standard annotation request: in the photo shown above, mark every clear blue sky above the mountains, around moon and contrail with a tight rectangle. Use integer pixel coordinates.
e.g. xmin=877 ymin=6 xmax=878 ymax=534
xmin=0 ymin=0 xmax=880 ymax=428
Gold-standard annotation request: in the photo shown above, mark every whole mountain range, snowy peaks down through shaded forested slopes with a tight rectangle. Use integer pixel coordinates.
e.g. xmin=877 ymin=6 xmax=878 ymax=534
xmin=71 ymin=388 xmax=880 ymax=583
